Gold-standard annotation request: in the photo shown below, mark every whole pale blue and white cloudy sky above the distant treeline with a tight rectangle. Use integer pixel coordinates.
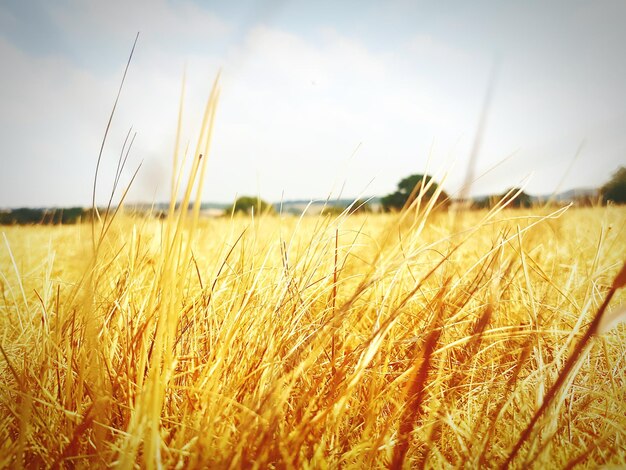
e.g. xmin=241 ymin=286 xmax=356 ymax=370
xmin=0 ymin=0 xmax=626 ymax=207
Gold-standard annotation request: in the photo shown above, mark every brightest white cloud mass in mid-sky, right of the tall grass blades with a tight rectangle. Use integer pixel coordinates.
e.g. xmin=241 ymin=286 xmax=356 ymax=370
xmin=200 ymin=27 xmax=482 ymax=199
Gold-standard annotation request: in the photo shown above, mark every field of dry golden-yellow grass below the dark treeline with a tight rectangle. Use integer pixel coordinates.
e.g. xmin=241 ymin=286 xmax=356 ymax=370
xmin=0 ymin=200 xmax=626 ymax=468
